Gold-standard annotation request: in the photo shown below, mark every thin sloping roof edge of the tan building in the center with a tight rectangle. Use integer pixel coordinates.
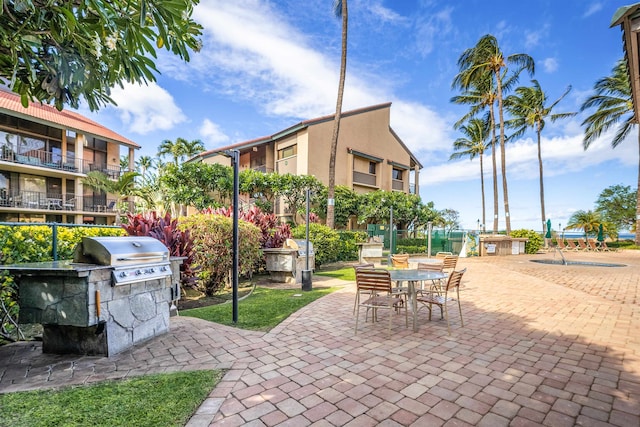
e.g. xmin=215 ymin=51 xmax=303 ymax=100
xmin=198 ymin=102 xmax=422 ymax=169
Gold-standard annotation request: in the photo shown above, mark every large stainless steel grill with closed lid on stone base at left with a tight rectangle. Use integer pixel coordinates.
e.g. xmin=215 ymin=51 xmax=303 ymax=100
xmin=73 ymin=236 xmax=171 ymax=286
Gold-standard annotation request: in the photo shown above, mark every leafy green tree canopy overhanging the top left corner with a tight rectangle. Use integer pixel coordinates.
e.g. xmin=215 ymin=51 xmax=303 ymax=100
xmin=0 ymin=0 xmax=202 ymax=111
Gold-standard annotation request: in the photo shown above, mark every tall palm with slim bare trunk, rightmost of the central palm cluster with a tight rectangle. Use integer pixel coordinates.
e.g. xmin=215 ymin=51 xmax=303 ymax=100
xmin=505 ymin=80 xmax=577 ymax=233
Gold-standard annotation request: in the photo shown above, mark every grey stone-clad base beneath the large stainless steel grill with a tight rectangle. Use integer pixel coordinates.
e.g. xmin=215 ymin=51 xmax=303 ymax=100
xmin=19 ymin=259 xmax=182 ymax=356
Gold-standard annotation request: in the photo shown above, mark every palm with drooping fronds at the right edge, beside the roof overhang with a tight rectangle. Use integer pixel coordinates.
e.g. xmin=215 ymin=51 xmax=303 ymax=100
xmin=580 ymin=59 xmax=640 ymax=245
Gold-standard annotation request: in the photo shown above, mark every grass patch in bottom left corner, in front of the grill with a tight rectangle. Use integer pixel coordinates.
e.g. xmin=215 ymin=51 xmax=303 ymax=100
xmin=0 ymin=371 xmax=222 ymax=427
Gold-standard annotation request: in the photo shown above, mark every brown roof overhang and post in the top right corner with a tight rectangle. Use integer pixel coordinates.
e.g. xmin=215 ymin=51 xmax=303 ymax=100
xmin=611 ymin=3 xmax=640 ymax=122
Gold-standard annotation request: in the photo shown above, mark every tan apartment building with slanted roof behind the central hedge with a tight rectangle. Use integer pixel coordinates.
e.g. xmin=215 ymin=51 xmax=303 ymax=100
xmin=193 ymin=102 xmax=422 ymax=222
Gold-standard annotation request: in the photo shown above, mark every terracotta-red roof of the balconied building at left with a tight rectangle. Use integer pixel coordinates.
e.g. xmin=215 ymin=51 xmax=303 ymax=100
xmin=0 ymin=88 xmax=140 ymax=148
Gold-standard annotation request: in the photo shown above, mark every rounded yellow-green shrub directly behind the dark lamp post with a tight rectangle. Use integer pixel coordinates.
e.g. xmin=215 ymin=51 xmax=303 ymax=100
xmin=178 ymin=214 xmax=262 ymax=295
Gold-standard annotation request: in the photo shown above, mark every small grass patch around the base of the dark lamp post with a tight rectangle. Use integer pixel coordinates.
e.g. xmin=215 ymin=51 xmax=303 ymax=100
xmin=180 ymin=287 xmax=338 ymax=331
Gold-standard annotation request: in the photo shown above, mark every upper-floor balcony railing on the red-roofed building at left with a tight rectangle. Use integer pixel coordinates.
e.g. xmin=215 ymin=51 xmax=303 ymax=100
xmin=0 ymin=146 xmax=121 ymax=179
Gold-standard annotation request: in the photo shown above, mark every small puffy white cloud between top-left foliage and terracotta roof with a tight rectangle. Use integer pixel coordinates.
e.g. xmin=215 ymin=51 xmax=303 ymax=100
xmin=109 ymin=83 xmax=187 ymax=135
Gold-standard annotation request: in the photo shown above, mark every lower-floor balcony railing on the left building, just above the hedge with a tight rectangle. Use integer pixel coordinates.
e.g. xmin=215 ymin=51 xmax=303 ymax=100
xmin=0 ymin=190 xmax=122 ymax=214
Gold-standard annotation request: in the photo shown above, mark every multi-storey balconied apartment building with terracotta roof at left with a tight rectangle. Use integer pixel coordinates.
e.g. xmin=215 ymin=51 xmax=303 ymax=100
xmin=0 ymin=89 xmax=140 ymax=224
